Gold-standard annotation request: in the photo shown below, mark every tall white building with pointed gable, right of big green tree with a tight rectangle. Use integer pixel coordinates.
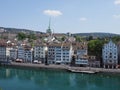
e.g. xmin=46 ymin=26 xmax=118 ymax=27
xmin=102 ymin=40 xmax=118 ymax=68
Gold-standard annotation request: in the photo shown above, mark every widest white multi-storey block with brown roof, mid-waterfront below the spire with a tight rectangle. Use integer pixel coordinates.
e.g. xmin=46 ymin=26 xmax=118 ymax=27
xmin=48 ymin=43 xmax=73 ymax=64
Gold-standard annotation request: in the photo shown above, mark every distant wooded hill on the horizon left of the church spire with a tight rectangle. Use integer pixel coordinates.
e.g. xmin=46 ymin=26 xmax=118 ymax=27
xmin=0 ymin=27 xmax=43 ymax=33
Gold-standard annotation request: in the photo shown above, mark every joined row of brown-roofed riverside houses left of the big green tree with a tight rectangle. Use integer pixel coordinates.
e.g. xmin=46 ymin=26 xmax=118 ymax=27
xmin=0 ymin=42 xmax=91 ymax=64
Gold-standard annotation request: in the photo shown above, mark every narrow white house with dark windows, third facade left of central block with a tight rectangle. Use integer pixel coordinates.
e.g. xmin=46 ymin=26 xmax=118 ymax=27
xmin=24 ymin=46 xmax=33 ymax=63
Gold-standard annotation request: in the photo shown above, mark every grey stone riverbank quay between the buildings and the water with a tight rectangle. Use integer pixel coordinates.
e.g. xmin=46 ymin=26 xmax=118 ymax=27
xmin=2 ymin=62 xmax=120 ymax=74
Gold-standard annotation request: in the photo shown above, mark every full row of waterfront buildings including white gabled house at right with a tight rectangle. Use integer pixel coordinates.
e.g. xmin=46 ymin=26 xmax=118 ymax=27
xmin=0 ymin=40 xmax=120 ymax=68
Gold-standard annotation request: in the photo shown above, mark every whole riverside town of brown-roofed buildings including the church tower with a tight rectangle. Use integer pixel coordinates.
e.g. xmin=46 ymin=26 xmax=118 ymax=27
xmin=0 ymin=25 xmax=120 ymax=69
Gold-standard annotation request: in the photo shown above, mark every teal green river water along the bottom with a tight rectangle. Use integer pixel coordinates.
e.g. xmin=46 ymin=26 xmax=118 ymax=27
xmin=0 ymin=67 xmax=120 ymax=90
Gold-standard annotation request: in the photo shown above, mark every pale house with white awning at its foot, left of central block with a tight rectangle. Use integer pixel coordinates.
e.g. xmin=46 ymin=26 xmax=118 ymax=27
xmin=34 ymin=44 xmax=46 ymax=63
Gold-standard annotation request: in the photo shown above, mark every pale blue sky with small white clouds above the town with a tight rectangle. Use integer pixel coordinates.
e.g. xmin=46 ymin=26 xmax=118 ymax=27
xmin=0 ymin=0 xmax=120 ymax=34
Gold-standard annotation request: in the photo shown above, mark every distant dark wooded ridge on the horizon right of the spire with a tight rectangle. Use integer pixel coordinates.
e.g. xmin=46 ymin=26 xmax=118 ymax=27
xmin=72 ymin=32 xmax=120 ymax=38
